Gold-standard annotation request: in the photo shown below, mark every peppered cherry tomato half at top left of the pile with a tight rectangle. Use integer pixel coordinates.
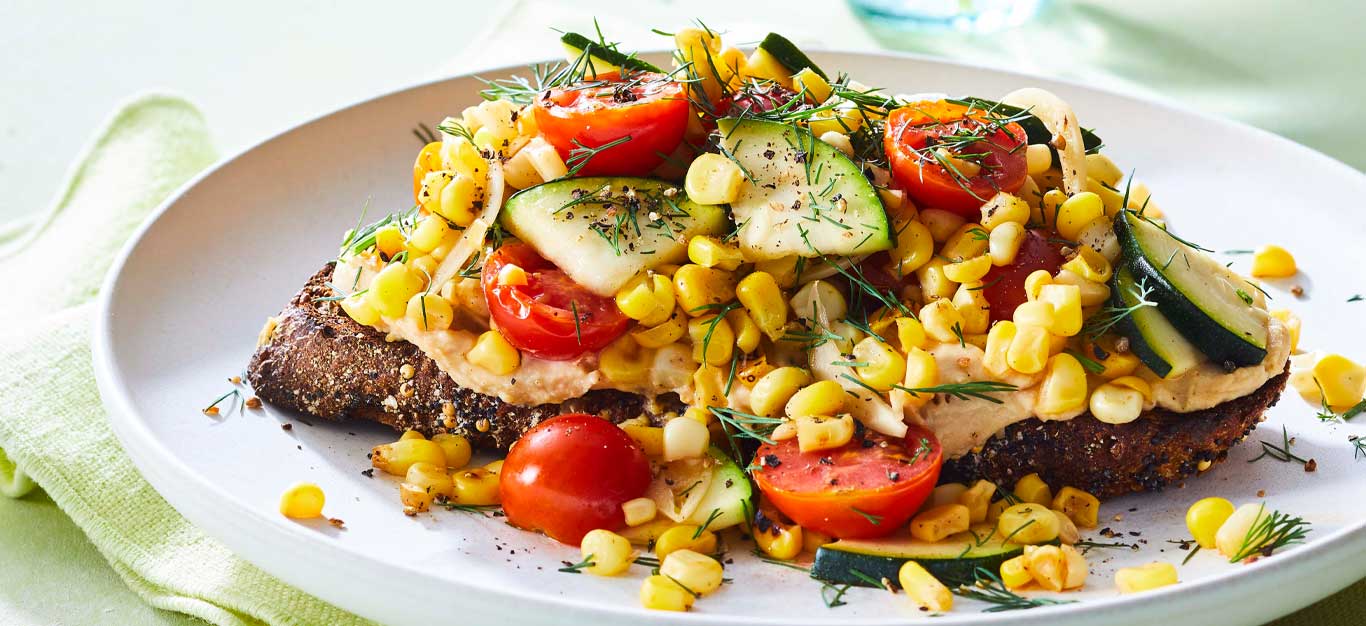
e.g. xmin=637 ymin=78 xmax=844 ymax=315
xmin=534 ymin=74 xmax=688 ymax=176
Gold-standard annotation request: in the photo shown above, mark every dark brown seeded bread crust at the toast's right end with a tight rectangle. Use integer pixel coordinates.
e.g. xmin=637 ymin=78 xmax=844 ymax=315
xmin=940 ymin=370 xmax=1290 ymax=499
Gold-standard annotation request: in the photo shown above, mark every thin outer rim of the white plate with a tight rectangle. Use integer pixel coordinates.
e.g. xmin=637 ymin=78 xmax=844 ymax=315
xmin=92 ymin=46 xmax=1366 ymax=626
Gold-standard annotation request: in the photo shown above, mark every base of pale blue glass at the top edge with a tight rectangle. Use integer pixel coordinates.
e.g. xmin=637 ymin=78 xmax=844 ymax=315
xmin=850 ymin=0 xmax=1045 ymax=33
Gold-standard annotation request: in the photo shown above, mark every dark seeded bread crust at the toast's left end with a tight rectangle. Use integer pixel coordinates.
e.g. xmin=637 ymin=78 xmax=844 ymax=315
xmin=247 ymin=264 xmax=682 ymax=450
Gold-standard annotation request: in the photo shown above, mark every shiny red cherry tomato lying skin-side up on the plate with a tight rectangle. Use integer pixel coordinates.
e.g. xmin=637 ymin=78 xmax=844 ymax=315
xmin=499 ymin=413 xmax=650 ymax=545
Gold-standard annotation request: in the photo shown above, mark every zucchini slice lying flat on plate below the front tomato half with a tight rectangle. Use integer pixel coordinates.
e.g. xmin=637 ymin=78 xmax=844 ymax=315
xmin=811 ymin=523 xmax=1025 ymax=586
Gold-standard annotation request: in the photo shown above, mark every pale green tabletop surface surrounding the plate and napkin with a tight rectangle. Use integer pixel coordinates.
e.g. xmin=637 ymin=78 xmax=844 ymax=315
xmin=0 ymin=0 xmax=1366 ymax=626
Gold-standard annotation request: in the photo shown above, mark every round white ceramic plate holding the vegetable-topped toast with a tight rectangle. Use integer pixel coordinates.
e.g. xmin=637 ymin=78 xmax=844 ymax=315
xmin=96 ymin=52 xmax=1366 ymax=626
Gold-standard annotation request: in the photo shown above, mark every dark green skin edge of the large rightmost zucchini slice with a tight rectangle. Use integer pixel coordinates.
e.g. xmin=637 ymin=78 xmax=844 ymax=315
xmin=1115 ymin=210 xmax=1266 ymax=368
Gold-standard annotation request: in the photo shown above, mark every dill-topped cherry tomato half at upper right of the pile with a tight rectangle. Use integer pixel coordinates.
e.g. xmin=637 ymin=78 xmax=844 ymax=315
xmin=884 ymin=100 xmax=1029 ymax=219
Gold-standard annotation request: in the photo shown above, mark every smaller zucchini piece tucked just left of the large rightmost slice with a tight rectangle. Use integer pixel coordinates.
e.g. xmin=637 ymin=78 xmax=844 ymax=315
xmin=1111 ymin=265 xmax=1201 ymax=379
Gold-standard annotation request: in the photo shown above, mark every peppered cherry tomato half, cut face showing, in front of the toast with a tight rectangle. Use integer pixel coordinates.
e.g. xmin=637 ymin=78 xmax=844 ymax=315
xmin=754 ymin=426 xmax=944 ymax=539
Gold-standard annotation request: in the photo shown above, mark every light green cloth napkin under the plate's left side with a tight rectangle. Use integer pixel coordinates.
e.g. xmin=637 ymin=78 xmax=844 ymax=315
xmin=0 ymin=96 xmax=366 ymax=625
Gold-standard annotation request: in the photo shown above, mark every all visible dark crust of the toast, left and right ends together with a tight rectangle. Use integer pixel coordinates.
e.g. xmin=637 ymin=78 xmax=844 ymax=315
xmin=247 ymin=264 xmax=1290 ymax=498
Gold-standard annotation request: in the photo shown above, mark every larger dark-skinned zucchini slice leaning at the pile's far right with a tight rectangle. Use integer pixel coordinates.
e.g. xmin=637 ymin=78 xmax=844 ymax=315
xmin=1115 ymin=210 xmax=1268 ymax=368
